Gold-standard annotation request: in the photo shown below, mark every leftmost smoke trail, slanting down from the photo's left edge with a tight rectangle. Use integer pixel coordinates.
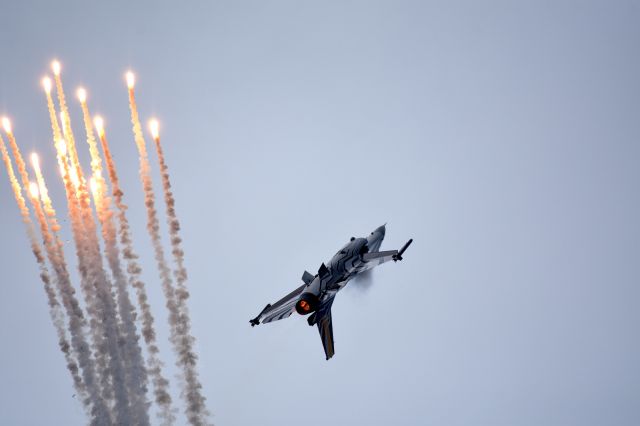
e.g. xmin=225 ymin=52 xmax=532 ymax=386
xmin=0 ymin=136 xmax=90 ymax=418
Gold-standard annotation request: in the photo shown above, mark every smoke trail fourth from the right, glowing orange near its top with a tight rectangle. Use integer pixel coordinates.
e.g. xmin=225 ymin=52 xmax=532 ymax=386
xmin=78 ymin=96 xmax=149 ymax=425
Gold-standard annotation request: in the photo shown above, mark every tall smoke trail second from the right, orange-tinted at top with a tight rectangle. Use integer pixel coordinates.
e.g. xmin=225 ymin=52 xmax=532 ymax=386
xmin=127 ymin=74 xmax=208 ymax=425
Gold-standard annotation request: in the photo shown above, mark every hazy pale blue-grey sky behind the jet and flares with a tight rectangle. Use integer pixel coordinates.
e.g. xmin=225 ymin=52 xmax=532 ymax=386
xmin=0 ymin=0 xmax=640 ymax=426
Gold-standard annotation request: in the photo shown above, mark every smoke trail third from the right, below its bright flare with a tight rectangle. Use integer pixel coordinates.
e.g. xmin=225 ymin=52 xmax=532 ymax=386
xmin=96 ymin=118 xmax=175 ymax=424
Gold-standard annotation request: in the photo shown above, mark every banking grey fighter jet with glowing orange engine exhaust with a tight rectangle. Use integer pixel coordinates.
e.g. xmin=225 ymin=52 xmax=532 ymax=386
xmin=249 ymin=225 xmax=413 ymax=360
